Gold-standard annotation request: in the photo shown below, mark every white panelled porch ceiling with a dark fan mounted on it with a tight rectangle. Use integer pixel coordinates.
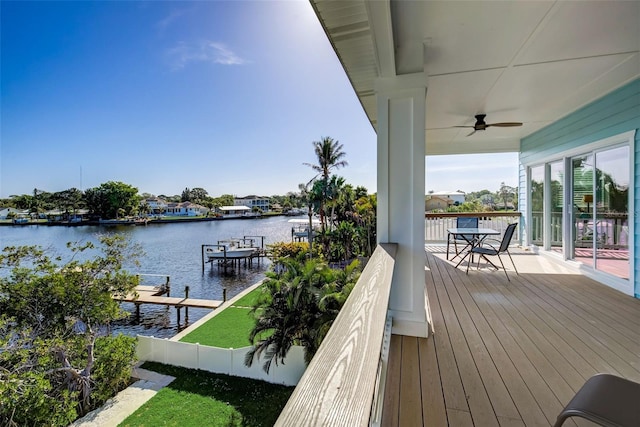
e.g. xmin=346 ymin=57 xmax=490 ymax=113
xmin=311 ymin=0 xmax=640 ymax=155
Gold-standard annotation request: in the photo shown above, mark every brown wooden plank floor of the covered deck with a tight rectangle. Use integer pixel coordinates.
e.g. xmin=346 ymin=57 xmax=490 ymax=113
xmin=382 ymin=246 xmax=640 ymax=427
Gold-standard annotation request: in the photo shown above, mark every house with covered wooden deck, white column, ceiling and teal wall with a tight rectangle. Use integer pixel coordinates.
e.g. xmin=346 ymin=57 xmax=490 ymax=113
xmin=278 ymin=0 xmax=640 ymax=426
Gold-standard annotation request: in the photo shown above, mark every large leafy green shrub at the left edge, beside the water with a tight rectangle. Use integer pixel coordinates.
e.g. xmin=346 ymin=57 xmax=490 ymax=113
xmin=0 ymin=236 xmax=139 ymax=426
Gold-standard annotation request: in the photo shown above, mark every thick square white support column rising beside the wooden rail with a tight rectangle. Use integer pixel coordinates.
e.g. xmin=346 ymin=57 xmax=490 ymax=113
xmin=376 ymin=73 xmax=429 ymax=337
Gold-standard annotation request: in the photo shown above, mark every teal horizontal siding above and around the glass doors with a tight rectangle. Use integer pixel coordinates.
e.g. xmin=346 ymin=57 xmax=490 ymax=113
xmin=520 ymin=79 xmax=640 ymax=298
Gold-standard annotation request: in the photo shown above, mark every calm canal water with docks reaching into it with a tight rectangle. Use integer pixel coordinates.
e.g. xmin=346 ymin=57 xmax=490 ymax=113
xmin=0 ymin=217 xmax=304 ymax=337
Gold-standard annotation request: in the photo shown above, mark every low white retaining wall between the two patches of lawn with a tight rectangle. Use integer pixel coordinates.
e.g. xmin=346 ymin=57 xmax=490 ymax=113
xmin=137 ymin=335 xmax=306 ymax=386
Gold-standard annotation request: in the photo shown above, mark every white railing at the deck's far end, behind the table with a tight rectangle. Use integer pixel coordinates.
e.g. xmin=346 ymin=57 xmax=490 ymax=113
xmin=424 ymin=212 xmax=521 ymax=243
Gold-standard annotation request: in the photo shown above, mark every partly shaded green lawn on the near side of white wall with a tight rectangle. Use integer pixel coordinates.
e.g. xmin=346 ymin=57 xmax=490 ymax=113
xmin=120 ymin=362 xmax=294 ymax=427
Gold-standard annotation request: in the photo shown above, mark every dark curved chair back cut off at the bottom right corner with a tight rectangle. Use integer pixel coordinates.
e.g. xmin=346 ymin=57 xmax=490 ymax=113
xmin=554 ymin=374 xmax=640 ymax=427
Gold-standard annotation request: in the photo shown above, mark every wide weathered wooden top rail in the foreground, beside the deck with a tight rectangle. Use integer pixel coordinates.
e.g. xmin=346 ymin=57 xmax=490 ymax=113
xmin=276 ymin=243 xmax=397 ymax=427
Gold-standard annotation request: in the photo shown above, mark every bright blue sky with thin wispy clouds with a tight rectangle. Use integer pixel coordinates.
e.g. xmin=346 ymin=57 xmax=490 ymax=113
xmin=0 ymin=0 xmax=517 ymax=197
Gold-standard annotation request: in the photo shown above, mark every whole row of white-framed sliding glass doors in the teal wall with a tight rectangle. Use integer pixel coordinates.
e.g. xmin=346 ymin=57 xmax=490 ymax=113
xmin=527 ymin=134 xmax=633 ymax=288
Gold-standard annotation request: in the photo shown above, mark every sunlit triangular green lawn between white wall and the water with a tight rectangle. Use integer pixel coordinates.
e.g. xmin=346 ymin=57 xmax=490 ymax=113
xmin=180 ymin=286 xmax=268 ymax=348
